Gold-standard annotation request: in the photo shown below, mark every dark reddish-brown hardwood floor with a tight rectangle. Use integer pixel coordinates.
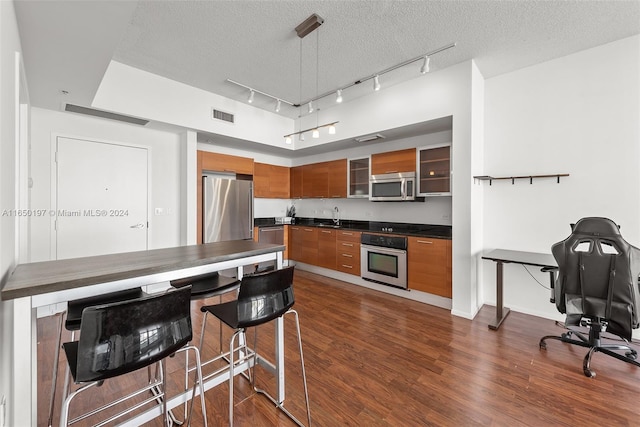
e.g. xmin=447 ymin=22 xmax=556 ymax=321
xmin=38 ymin=271 xmax=640 ymax=427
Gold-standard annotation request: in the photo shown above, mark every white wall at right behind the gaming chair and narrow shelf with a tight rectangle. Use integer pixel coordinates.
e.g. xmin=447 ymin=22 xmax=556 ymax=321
xmin=476 ymin=36 xmax=640 ymax=324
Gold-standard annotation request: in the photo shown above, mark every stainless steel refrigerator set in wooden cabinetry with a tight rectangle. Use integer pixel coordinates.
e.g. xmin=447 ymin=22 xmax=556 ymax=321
xmin=202 ymin=176 xmax=253 ymax=243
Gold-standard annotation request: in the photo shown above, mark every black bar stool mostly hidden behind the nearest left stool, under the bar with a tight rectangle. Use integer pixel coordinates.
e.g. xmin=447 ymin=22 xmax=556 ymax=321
xmin=47 ymin=288 xmax=145 ymax=427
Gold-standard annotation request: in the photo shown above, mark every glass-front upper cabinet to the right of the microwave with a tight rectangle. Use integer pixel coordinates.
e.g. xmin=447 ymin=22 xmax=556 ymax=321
xmin=416 ymin=144 xmax=451 ymax=196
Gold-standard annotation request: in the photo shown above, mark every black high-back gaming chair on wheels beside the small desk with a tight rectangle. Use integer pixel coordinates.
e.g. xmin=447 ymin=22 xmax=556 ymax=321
xmin=540 ymin=218 xmax=640 ymax=377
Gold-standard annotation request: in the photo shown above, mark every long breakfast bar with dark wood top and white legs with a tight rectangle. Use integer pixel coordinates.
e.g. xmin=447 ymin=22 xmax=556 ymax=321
xmin=0 ymin=240 xmax=285 ymax=426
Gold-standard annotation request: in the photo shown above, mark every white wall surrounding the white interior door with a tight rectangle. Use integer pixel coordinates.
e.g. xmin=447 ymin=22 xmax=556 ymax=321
xmin=31 ymin=108 xmax=185 ymax=261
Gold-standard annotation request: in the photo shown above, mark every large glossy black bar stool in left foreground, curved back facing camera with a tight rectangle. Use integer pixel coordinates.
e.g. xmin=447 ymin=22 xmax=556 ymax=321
xmin=60 ymin=287 xmax=207 ymax=426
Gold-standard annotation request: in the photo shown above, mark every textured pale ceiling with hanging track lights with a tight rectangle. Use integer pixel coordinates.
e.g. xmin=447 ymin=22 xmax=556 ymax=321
xmin=16 ymin=0 xmax=640 ymax=117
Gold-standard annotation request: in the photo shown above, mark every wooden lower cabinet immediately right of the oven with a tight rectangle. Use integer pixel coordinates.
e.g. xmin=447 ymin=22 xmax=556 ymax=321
xmin=407 ymin=237 xmax=452 ymax=298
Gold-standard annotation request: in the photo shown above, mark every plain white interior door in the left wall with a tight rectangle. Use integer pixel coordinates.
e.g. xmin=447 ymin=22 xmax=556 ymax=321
xmin=55 ymin=137 xmax=148 ymax=259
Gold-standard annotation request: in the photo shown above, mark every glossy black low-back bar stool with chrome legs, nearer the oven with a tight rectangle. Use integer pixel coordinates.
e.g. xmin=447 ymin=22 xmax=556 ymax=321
xmin=200 ymin=266 xmax=311 ymax=426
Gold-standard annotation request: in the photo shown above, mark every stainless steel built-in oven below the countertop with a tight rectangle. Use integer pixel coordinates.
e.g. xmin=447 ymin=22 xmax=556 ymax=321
xmin=360 ymin=233 xmax=407 ymax=289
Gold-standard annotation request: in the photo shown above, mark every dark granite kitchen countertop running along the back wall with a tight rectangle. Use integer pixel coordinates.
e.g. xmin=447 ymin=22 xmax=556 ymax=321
xmin=254 ymin=217 xmax=451 ymax=239
